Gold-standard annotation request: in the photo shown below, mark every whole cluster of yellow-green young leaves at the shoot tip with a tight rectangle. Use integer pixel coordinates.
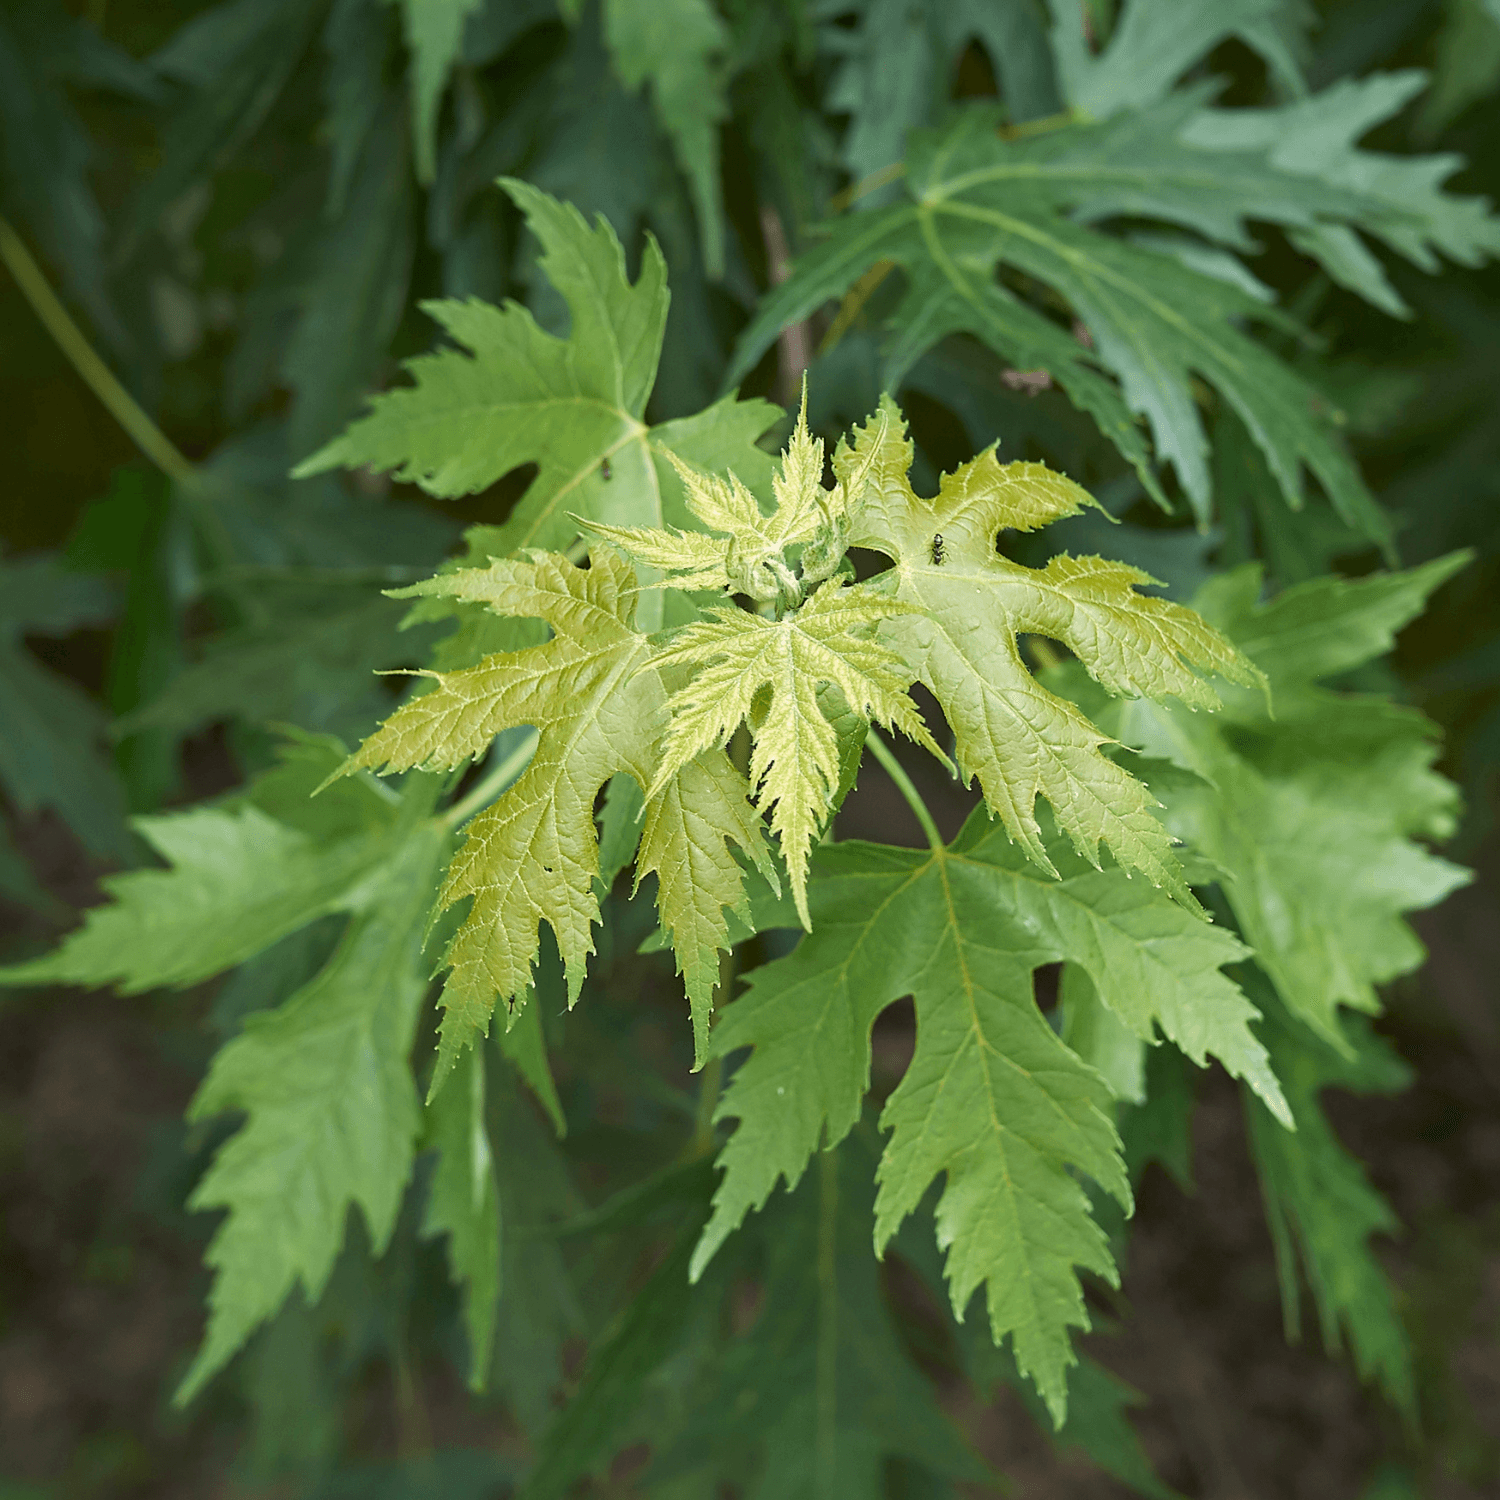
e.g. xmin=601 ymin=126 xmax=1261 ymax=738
xmin=325 ymin=381 xmax=1259 ymax=1104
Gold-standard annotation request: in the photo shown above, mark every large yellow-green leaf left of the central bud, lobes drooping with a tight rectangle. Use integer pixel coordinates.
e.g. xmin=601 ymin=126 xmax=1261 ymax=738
xmin=336 ymin=546 xmax=765 ymax=1088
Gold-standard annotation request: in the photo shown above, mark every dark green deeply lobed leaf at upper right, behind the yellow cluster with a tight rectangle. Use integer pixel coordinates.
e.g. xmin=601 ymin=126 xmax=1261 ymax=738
xmin=729 ymin=99 xmax=1410 ymax=540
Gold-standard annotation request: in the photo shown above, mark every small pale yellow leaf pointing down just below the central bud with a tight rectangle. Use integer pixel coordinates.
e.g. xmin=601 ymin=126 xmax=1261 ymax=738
xmin=651 ymin=581 xmax=944 ymax=927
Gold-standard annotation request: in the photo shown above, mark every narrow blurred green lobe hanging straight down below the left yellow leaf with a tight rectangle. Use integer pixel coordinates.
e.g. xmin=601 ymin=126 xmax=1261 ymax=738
xmin=422 ymin=1047 xmax=501 ymax=1391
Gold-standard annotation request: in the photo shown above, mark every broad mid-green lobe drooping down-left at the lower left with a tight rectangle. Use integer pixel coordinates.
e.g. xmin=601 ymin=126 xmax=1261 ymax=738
xmin=174 ymin=824 xmax=447 ymax=1404
